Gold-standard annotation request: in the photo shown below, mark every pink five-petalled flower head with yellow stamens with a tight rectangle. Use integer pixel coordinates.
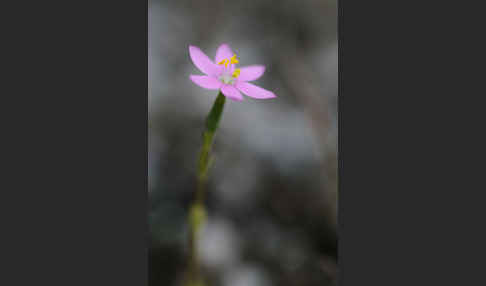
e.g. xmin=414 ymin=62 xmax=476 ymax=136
xmin=189 ymin=44 xmax=276 ymax=101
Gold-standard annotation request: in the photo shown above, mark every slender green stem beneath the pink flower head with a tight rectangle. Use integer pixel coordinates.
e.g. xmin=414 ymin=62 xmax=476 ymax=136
xmin=187 ymin=92 xmax=226 ymax=286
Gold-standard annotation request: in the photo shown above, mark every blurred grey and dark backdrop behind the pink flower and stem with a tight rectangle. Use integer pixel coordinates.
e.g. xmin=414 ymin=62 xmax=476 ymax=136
xmin=148 ymin=0 xmax=338 ymax=286
